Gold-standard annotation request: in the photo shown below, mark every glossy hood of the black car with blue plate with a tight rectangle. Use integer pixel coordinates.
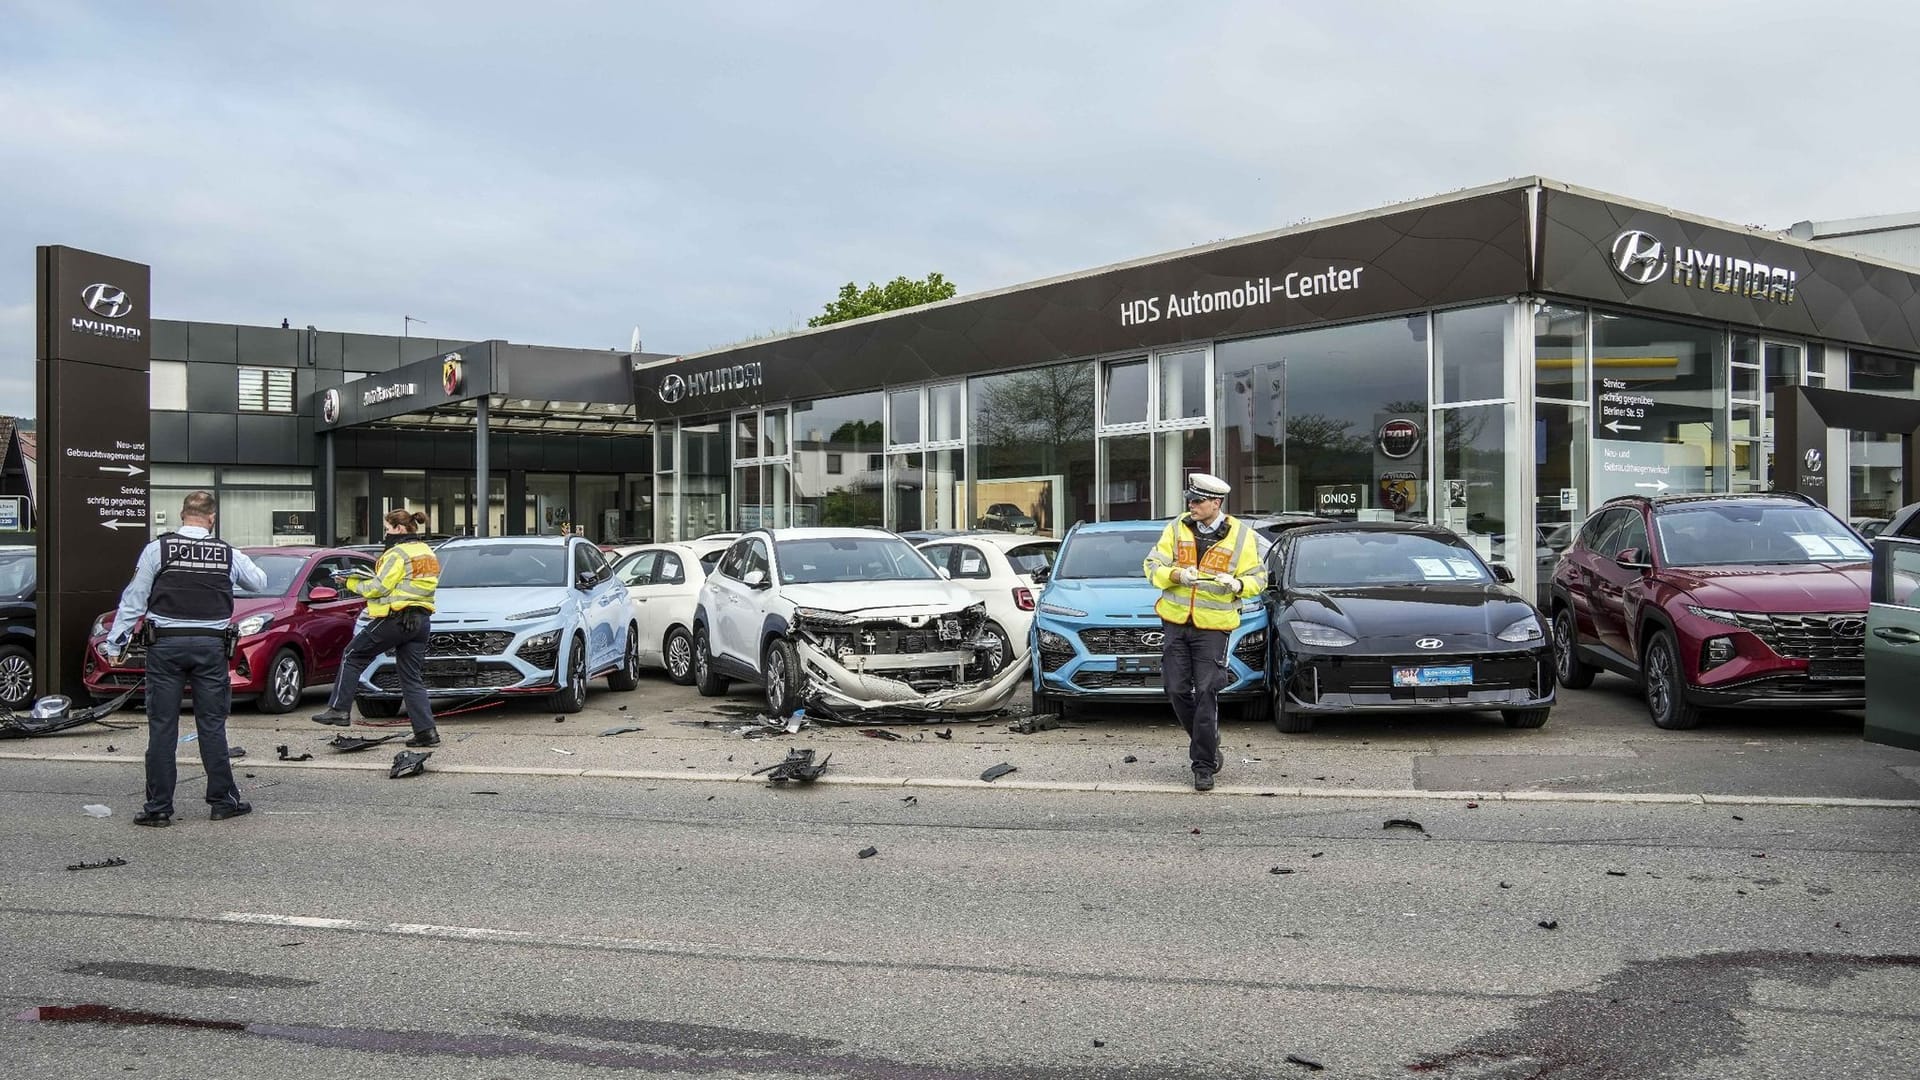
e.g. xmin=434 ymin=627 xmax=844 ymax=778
xmin=1286 ymin=584 xmax=1538 ymax=640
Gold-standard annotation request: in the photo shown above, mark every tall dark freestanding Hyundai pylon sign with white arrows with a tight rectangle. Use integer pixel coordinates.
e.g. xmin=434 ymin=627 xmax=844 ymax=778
xmin=35 ymin=246 xmax=154 ymax=696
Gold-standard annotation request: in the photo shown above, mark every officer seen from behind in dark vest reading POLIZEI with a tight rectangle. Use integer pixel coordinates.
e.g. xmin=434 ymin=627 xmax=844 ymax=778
xmin=106 ymin=492 xmax=267 ymax=828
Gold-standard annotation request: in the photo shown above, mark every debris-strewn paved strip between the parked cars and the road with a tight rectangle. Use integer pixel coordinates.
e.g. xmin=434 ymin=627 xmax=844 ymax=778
xmin=0 ymin=676 xmax=1920 ymax=807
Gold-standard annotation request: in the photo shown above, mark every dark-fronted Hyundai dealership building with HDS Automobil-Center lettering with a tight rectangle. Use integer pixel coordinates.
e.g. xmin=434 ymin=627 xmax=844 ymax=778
xmin=60 ymin=179 xmax=1920 ymax=607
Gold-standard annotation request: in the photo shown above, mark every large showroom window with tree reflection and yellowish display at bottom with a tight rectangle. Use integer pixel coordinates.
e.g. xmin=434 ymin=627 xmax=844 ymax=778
xmin=968 ymin=361 xmax=1098 ymax=536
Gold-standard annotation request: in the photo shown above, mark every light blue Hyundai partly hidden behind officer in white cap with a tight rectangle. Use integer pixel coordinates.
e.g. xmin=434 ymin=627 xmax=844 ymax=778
xmin=1027 ymin=521 xmax=1271 ymax=719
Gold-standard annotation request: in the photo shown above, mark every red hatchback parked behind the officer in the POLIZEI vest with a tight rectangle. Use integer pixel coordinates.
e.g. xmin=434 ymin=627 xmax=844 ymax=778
xmin=83 ymin=548 xmax=372 ymax=713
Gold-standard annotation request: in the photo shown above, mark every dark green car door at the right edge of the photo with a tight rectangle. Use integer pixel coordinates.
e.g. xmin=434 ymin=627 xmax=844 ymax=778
xmin=1864 ymin=519 xmax=1920 ymax=749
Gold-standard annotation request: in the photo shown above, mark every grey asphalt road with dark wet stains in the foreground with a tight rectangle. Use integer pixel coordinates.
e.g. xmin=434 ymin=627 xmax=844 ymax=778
xmin=0 ymin=749 xmax=1920 ymax=1080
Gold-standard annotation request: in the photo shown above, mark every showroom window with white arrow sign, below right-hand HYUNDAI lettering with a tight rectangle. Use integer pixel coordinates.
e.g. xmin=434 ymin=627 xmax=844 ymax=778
xmin=1592 ymin=311 xmax=1728 ymax=502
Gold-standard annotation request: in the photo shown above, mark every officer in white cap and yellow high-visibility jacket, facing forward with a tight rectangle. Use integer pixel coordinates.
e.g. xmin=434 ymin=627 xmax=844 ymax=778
xmin=1144 ymin=473 xmax=1267 ymax=792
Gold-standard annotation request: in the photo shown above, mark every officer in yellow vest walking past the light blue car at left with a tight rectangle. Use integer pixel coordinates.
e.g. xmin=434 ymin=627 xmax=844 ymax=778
xmin=313 ymin=509 xmax=440 ymax=746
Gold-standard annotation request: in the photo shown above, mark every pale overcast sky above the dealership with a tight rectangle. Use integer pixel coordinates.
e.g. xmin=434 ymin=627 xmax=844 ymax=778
xmin=0 ymin=0 xmax=1920 ymax=413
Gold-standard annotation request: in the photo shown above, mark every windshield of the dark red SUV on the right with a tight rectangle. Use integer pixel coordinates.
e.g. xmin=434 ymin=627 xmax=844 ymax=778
xmin=1653 ymin=500 xmax=1870 ymax=567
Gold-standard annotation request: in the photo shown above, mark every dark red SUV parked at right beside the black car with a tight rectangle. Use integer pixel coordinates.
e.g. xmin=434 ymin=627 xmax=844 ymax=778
xmin=1548 ymin=494 xmax=1870 ymax=728
